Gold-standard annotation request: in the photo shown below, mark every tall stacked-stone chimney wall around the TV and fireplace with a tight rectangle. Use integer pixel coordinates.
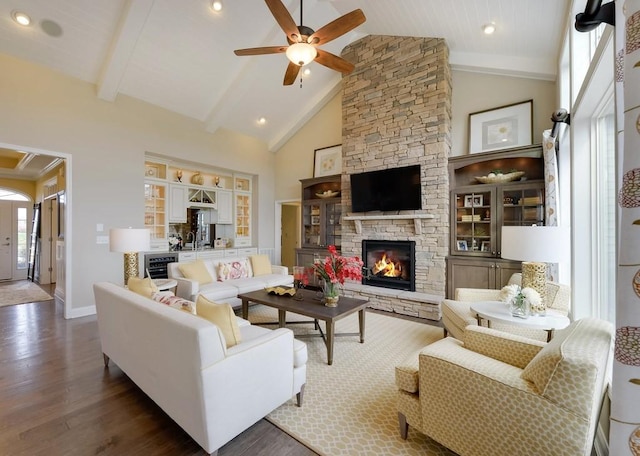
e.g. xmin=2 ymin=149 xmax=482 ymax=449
xmin=342 ymin=36 xmax=451 ymax=319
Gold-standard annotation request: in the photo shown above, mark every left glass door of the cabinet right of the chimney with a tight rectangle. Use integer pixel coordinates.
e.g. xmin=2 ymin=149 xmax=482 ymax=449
xmin=452 ymin=189 xmax=496 ymax=256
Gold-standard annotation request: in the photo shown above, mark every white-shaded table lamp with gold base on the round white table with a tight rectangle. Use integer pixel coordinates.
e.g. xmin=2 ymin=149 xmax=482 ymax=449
xmin=501 ymin=225 xmax=571 ymax=307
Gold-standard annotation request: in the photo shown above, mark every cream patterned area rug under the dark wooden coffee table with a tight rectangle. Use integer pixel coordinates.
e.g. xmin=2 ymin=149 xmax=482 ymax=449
xmin=249 ymin=306 xmax=454 ymax=456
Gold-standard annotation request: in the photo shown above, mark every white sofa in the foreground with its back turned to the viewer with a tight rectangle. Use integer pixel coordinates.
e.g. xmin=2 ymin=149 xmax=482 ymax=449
xmin=93 ymin=282 xmax=307 ymax=455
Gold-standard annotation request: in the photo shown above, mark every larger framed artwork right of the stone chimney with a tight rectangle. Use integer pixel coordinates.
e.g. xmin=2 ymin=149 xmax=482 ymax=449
xmin=469 ymin=100 xmax=533 ymax=154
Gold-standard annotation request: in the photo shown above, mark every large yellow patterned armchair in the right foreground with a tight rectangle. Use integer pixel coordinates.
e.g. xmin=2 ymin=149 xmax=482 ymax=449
xmin=396 ymin=318 xmax=613 ymax=456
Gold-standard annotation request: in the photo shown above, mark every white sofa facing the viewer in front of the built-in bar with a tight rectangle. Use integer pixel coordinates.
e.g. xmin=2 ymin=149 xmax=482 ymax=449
xmin=167 ymin=257 xmax=293 ymax=307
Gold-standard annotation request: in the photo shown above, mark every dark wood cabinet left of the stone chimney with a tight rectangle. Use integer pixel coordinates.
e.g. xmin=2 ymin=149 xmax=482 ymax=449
xmin=296 ymin=174 xmax=342 ymax=286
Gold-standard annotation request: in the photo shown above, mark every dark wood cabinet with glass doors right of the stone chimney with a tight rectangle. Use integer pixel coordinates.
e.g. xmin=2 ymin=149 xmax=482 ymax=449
xmin=447 ymin=145 xmax=545 ymax=298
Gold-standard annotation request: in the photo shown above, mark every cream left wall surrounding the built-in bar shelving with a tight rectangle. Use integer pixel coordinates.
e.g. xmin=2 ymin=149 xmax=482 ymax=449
xmin=0 ymin=55 xmax=275 ymax=316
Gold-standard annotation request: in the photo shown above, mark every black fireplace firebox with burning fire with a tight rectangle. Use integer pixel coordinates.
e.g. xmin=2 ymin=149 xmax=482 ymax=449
xmin=362 ymin=239 xmax=416 ymax=291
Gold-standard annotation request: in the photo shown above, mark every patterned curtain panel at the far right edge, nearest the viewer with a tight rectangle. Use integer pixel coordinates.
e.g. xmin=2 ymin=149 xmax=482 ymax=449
xmin=609 ymin=0 xmax=640 ymax=456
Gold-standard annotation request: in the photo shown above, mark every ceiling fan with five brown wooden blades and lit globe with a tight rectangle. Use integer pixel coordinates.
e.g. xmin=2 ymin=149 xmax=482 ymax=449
xmin=234 ymin=0 xmax=366 ymax=85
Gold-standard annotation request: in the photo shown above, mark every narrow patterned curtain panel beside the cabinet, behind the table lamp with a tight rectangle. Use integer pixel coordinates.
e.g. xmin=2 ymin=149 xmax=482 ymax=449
xmin=542 ymin=130 xmax=559 ymax=282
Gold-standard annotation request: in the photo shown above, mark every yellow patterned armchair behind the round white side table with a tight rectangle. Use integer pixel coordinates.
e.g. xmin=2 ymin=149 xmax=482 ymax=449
xmin=442 ymin=273 xmax=571 ymax=341
